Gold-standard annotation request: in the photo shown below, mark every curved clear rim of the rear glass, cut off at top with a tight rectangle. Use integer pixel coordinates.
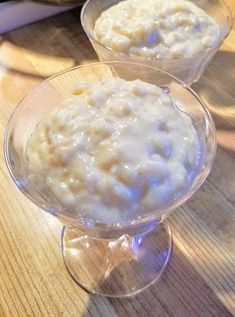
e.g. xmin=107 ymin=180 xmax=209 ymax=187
xmin=80 ymin=0 xmax=233 ymax=63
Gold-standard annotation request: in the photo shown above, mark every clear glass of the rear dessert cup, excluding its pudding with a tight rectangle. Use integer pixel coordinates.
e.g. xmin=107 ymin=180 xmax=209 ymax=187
xmin=81 ymin=0 xmax=232 ymax=85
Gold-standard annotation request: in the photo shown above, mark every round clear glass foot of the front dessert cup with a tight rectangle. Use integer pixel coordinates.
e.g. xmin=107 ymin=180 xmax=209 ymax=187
xmin=62 ymin=224 xmax=172 ymax=297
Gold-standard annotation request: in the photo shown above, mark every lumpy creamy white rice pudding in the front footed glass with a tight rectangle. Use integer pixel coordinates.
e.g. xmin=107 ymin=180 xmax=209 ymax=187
xmin=27 ymin=78 xmax=200 ymax=223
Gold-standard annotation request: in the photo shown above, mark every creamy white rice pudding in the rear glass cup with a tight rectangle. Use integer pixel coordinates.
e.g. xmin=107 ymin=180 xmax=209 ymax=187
xmin=94 ymin=0 xmax=220 ymax=59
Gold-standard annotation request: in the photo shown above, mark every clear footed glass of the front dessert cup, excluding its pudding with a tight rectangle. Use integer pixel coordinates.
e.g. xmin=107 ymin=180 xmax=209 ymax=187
xmin=4 ymin=62 xmax=216 ymax=297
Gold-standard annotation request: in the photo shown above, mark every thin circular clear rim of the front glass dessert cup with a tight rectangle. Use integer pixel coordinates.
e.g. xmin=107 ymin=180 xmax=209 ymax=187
xmin=3 ymin=61 xmax=217 ymax=231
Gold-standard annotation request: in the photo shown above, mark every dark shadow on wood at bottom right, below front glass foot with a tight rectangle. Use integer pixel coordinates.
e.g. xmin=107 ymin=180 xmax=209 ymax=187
xmin=83 ymin=239 xmax=232 ymax=317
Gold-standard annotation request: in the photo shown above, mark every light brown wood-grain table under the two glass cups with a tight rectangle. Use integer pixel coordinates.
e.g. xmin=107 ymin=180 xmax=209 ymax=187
xmin=0 ymin=0 xmax=235 ymax=317
